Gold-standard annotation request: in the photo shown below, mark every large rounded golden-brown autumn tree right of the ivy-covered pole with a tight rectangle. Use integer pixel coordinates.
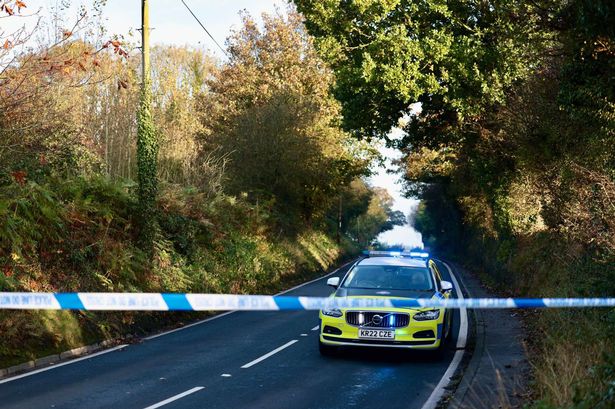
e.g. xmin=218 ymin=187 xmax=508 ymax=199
xmin=200 ymin=11 xmax=373 ymax=231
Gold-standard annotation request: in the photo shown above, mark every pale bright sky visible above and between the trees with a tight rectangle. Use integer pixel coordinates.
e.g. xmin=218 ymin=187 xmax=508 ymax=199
xmin=18 ymin=0 xmax=422 ymax=247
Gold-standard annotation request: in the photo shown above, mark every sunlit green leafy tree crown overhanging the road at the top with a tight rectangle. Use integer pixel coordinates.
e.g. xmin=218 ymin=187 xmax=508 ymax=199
xmin=295 ymin=0 xmax=549 ymax=139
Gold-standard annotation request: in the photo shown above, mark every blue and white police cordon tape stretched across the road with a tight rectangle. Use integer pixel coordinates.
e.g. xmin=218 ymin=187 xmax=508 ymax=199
xmin=0 ymin=292 xmax=615 ymax=311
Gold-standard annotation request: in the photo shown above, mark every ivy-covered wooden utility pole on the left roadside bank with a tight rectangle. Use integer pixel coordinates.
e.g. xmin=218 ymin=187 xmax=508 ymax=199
xmin=137 ymin=0 xmax=158 ymax=254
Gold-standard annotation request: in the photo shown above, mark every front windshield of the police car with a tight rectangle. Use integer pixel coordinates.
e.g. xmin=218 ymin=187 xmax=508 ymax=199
xmin=342 ymin=266 xmax=433 ymax=291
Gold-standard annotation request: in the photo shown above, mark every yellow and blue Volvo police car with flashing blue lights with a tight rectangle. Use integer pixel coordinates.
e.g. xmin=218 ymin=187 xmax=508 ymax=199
xmin=319 ymin=252 xmax=453 ymax=355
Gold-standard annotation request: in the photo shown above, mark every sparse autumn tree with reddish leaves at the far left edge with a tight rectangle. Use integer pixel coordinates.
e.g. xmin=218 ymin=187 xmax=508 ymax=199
xmin=0 ymin=1 xmax=126 ymax=183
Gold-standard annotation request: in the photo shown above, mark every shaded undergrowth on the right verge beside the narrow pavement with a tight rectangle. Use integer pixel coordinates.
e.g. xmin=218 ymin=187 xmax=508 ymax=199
xmin=416 ymin=190 xmax=615 ymax=409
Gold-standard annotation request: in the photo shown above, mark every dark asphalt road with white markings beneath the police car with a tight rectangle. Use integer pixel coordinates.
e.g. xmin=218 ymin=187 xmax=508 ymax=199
xmin=0 ymin=265 xmax=470 ymax=409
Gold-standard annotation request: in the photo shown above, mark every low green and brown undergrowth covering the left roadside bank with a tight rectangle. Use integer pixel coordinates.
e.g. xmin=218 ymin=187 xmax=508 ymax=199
xmin=0 ymin=177 xmax=354 ymax=367
